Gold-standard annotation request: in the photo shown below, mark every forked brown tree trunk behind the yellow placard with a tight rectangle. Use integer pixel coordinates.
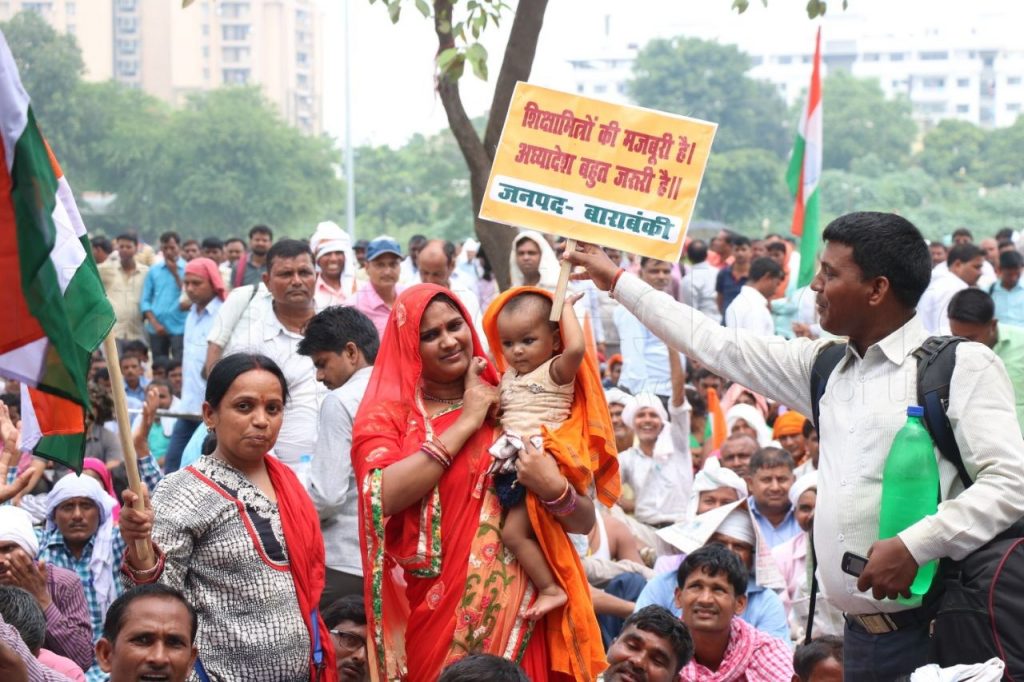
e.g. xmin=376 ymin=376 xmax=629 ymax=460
xmin=434 ymin=0 xmax=548 ymax=289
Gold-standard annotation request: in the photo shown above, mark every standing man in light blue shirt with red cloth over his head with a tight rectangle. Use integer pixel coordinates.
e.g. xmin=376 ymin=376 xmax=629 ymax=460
xmin=164 ymin=258 xmax=225 ymax=473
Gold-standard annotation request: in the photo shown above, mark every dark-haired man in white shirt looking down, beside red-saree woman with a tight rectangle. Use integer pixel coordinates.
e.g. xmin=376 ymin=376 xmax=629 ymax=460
xmin=298 ymin=306 xmax=380 ymax=608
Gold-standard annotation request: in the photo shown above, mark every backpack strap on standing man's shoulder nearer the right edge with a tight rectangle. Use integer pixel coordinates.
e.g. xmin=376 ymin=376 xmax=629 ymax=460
xmin=913 ymin=336 xmax=974 ymax=487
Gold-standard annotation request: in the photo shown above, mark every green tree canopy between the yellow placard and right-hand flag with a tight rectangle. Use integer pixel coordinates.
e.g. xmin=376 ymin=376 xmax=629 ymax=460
xmin=627 ymin=38 xmax=793 ymax=158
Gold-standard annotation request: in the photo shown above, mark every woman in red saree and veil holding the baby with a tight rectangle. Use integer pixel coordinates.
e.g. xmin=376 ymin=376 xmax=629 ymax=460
xmin=352 ymin=285 xmax=594 ymax=682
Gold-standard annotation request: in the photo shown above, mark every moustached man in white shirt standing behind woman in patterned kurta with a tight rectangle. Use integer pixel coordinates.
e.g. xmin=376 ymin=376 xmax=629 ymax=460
xmin=206 ymin=240 xmax=321 ymax=467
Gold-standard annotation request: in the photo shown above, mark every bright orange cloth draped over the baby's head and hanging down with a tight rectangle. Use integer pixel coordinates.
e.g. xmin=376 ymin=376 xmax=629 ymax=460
xmin=483 ymin=287 xmax=620 ymax=680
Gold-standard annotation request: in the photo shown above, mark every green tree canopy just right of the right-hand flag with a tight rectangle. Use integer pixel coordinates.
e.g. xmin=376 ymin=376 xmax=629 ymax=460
xmin=819 ymin=71 xmax=918 ymax=171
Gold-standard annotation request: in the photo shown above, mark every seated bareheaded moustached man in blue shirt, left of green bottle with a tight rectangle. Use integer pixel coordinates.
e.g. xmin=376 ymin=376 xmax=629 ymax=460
xmin=748 ymin=447 xmax=800 ymax=547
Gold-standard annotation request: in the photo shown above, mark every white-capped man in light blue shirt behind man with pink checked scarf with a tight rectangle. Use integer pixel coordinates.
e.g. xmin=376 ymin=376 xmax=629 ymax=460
xmin=636 ymin=503 xmax=790 ymax=640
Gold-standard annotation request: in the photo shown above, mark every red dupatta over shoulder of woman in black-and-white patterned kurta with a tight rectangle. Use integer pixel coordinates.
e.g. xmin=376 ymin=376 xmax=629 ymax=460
xmin=264 ymin=450 xmax=338 ymax=682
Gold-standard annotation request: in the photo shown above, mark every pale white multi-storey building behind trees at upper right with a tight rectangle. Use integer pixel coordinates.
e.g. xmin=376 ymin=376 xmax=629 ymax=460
xmin=561 ymin=8 xmax=1024 ymax=129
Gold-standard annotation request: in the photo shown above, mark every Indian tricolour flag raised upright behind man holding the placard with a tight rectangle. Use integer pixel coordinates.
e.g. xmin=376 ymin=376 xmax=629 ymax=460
xmin=785 ymin=28 xmax=822 ymax=287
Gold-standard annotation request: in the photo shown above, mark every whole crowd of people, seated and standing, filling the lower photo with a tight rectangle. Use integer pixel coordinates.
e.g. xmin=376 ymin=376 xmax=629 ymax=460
xmin=0 ymin=213 xmax=1024 ymax=682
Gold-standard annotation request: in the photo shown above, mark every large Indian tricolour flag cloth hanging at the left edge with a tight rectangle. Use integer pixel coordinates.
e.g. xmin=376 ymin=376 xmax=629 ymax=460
xmin=0 ymin=33 xmax=114 ymax=469
